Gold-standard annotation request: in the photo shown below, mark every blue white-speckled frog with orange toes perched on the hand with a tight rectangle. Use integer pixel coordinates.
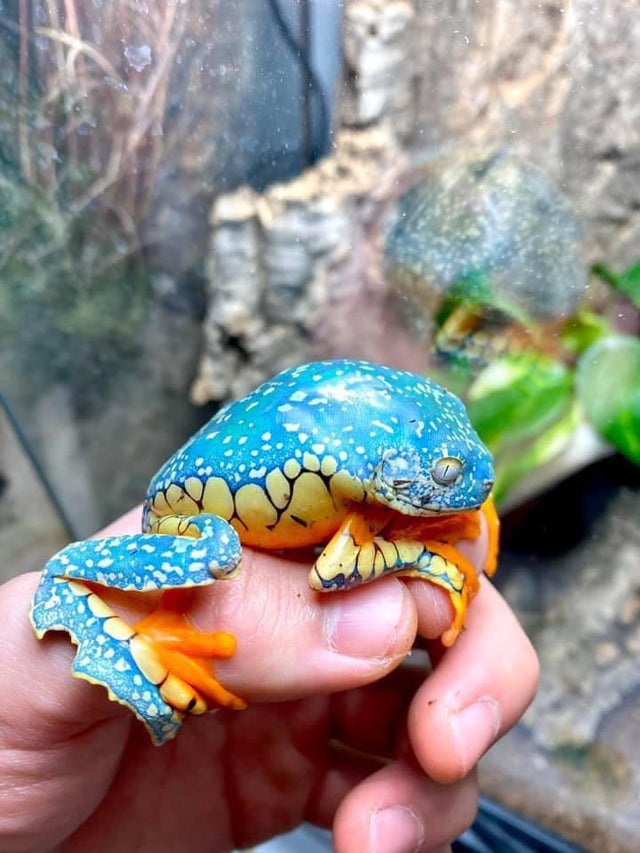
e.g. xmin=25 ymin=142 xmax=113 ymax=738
xmin=31 ymin=359 xmax=499 ymax=745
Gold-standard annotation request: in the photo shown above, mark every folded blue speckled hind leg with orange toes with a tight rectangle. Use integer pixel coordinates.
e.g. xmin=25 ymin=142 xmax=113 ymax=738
xmin=31 ymin=515 xmax=245 ymax=744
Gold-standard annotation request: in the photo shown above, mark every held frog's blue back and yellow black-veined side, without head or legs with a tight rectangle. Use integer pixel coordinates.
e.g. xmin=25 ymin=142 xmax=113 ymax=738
xmin=142 ymin=360 xmax=488 ymax=547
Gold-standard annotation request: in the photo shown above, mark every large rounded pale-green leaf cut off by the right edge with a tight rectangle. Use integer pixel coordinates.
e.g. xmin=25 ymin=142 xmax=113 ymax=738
xmin=576 ymin=335 xmax=640 ymax=465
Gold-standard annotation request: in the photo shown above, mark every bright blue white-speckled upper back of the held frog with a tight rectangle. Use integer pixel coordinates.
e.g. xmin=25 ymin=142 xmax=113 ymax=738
xmin=151 ymin=360 xmax=486 ymax=520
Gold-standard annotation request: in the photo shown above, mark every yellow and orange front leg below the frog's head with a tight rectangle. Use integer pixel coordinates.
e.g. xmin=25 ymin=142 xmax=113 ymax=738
xmin=309 ymin=505 xmax=488 ymax=646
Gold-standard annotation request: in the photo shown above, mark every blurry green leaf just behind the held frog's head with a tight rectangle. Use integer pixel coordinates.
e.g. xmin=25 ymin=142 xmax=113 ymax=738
xmin=467 ymin=352 xmax=573 ymax=453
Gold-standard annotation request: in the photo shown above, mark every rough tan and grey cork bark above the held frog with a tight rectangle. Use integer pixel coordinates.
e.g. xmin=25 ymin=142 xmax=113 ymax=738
xmin=192 ymin=0 xmax=640 ymax=402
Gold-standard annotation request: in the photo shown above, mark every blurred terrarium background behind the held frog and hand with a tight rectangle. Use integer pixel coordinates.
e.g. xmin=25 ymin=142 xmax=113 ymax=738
xmin=0 ymin=0 xmax=640 ymax=851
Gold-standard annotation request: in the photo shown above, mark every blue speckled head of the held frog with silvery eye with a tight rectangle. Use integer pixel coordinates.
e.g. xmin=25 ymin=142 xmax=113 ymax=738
xmin=373 ymin=398 xmax=494 ymax=516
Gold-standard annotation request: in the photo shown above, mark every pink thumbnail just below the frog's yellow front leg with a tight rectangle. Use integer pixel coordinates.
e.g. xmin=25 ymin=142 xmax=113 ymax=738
xmin=325 ymin=582 xmax=408 ymax=658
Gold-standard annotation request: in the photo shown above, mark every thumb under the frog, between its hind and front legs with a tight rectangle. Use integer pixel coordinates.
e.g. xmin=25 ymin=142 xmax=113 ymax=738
xmin=190 ymin=548 xmax=417 ymax=701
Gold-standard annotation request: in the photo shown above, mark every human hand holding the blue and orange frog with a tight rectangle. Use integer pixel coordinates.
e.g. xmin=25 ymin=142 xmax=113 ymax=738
xmin=0 ymin=510 xmax=538 ymax=853
